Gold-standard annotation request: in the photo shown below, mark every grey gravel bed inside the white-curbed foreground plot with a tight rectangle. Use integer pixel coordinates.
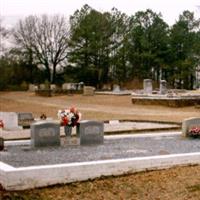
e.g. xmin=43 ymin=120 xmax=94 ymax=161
xmin=0 ymin=134 xmax=200 ymax=167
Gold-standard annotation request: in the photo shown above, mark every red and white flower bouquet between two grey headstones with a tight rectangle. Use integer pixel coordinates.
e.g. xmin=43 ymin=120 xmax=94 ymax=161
xmin=58 ymin=107 xmax=81 ymax=127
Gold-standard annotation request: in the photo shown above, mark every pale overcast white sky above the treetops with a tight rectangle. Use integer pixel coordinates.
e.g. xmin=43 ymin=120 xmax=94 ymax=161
xmin=0 ymin=0 xmax=200 ymax=25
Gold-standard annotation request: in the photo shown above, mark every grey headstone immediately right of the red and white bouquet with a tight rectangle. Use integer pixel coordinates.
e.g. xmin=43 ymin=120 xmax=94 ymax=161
xmin=77 ymin=120 xmax=104 ymax=145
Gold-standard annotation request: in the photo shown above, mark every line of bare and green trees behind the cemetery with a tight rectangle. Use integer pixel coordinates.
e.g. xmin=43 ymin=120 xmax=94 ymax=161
xmin=0 ymin=5 xmax=200 ymax=90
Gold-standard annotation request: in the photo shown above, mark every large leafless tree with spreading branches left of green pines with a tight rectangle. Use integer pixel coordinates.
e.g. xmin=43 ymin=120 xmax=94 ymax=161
xmin=14 ymin=15 xmax=69 ymax=83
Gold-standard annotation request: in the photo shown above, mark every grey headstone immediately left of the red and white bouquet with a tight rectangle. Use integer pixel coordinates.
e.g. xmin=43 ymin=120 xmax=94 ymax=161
xmin=31 ymin=121 xmax=60 ymax=147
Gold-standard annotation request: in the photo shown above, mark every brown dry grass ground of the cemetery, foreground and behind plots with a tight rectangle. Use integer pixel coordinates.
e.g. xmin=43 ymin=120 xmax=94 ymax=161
xmin=0 ymin=92 xmax=200 ymax=200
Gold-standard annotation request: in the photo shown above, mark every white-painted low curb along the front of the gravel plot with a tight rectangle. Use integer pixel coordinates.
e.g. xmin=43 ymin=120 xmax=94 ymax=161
xmin=0 ymin=152 xmax=200 ymax=190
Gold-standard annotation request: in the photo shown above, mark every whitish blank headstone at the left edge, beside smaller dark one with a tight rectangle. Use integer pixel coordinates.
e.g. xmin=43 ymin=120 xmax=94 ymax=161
xmin=0 ymin=112 xmax=22 ymax=130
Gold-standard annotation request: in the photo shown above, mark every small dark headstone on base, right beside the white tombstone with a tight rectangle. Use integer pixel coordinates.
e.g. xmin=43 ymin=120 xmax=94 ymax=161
xmin=17 ymin=112 xmax=34 ymax=127
